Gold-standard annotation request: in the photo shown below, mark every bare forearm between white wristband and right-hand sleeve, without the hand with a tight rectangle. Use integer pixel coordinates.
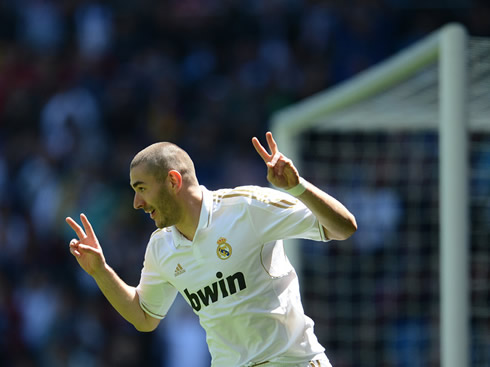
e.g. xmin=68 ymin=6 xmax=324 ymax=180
xmin=297 ymin=181 xmax=357 ymax=240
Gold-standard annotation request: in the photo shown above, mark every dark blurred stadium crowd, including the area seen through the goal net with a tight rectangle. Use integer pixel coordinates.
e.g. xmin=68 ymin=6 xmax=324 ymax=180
xmin=0 ymin=0 xmax=490 ymax=367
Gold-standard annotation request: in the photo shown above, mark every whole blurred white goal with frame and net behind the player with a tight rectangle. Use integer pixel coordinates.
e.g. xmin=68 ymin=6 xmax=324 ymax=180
xmin=272 ymin=24 xmax=490 ymax=367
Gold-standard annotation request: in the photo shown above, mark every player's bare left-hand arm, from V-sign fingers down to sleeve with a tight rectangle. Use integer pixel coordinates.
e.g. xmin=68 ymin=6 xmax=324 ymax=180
xmin=66 ymin=214 xmax=160 ymax=331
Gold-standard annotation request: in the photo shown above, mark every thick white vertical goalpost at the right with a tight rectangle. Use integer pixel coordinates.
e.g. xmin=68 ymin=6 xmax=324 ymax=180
xmin=439 ymin=26 xmax=470 ymax=367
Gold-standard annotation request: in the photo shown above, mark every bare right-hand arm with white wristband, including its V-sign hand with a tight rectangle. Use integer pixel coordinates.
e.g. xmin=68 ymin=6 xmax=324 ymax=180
xmin=252 ymin=132 xmax=357 ymax=240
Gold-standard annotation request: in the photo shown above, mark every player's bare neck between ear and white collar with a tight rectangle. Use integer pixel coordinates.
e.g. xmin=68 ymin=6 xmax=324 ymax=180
xmin=175 ymin=186 xmax=203 ymax=241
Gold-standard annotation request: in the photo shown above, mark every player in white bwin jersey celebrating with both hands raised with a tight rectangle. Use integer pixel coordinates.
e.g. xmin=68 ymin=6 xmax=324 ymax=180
xmin=66 ymin=132 xmax=357 ymax=367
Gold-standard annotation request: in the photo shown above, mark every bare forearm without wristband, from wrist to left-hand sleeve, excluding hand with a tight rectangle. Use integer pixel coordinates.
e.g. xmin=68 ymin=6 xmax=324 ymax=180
xmin=92 ymin=265 xmax=160 ymax=332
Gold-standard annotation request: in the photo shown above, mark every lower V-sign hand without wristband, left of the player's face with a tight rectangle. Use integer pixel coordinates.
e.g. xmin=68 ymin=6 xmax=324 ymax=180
xmin=66 ymin=214 xmax=105 ymax=276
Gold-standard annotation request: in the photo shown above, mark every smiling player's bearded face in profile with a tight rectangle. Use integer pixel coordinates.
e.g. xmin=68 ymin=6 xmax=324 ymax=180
xmin=129 ymin=164 xmax=181 ymax=228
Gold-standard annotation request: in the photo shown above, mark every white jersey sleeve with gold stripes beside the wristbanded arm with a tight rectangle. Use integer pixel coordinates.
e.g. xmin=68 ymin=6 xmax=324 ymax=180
xmin=249 ymin=188 xmax=328 ymax=246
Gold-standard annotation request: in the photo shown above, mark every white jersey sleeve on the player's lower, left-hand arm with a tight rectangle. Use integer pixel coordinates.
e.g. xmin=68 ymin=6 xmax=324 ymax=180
xmin=136 ymin=240 xmax=177 ymax=319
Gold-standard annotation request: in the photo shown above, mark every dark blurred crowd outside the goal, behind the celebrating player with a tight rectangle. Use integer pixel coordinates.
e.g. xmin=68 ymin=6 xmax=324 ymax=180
xmin=0 ymin=0 xmax=490 ymax=367
